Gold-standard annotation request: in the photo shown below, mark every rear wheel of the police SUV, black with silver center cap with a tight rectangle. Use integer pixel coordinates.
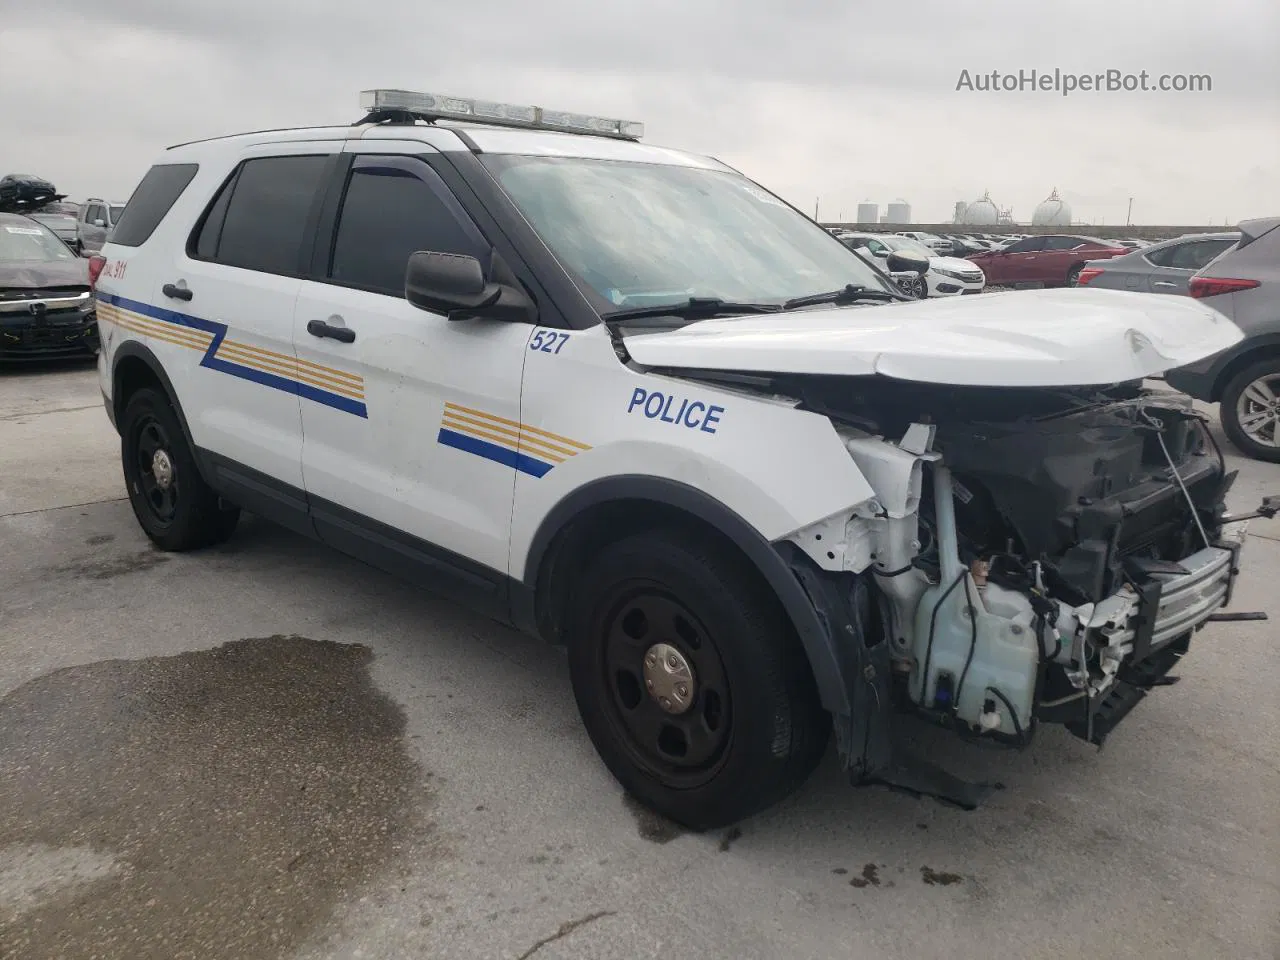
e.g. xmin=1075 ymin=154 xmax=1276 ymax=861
xmin=120 ymin=388 xmax=239 ymax=552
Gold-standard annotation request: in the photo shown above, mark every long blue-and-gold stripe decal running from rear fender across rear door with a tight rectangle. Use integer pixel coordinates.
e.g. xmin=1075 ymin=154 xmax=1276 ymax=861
xmin=97 ymin=293 xmax=369 ymax=419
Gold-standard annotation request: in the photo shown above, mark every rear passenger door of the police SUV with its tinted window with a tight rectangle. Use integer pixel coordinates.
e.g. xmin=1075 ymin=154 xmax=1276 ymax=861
xmin=156 ymin=142 xmax=347 ymax=530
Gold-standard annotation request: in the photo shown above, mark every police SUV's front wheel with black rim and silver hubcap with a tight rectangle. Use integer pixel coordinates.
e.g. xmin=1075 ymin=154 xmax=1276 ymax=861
xmin=567 ymin=530 xmax=829 ymax=829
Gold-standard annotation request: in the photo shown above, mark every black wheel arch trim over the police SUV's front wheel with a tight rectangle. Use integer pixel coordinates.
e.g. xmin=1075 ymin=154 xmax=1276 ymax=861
xmin=512 ymin=475 xmax=850 ymax=713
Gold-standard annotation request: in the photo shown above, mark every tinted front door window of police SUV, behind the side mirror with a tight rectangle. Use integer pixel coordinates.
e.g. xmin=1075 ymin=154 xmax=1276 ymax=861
xmin=329 ymin=157 xmax=490 ymax=297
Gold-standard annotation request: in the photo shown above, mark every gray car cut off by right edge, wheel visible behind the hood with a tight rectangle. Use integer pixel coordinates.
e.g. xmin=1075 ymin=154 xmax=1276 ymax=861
xmin=1167 ymin=216 xmax=1280 ymax=463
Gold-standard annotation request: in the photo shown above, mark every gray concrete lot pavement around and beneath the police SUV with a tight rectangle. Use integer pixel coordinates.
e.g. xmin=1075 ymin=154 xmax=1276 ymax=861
xmin=0 ymin=367 xmax=1280 ymax=960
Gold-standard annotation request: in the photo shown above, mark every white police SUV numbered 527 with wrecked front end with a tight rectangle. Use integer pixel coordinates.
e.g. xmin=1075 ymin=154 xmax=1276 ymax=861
xmin=92 ymin=90 xmax=1259 ymax=827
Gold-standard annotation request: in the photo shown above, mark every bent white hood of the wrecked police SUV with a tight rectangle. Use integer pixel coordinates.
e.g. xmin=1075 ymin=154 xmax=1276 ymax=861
xmin=626 ymin=288 xmax=1244 ymax=387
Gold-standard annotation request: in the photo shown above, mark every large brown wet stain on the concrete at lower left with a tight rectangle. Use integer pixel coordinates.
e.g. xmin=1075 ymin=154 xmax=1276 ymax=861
xmin=0 ymin=636 xmax=426 ymax=960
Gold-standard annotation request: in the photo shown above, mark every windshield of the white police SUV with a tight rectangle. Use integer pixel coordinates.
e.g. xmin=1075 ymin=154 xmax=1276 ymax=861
xmin=480 ymin=154 xmax=892 ymax=311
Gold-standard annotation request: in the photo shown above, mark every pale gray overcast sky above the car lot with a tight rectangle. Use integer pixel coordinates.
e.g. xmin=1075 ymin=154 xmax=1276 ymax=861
xmin=0 ymin=0 xmax=1280 ymax=224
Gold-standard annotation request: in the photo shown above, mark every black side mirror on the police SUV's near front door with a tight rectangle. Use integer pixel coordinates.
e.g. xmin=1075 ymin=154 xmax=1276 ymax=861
xmin=404 ymin=250 xmax=538 ymax=323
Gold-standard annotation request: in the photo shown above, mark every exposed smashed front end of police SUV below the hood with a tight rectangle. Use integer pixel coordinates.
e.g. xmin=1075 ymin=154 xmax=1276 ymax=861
xmin=787 ymin=378 xmax=1244 ymax=806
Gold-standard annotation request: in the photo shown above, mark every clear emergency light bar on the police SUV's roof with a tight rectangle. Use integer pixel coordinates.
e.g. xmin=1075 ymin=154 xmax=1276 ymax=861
xmin=360 ymin=90 xmax=644 ymax=140
